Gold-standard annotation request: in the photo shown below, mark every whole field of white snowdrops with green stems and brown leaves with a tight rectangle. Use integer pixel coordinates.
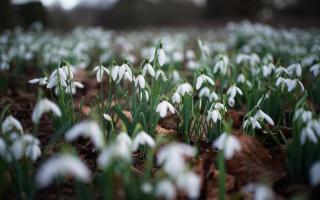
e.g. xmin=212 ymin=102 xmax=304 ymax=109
xmin=0 ymin=21 xmax=320 ymax=200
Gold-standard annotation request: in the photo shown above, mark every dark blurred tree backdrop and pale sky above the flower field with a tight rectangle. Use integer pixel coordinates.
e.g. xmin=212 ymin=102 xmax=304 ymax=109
xmin=0 ymin=0 xmax=320 ymax=31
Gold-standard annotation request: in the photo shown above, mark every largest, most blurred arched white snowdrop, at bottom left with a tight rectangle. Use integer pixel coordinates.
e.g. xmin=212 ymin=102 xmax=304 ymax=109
xmin=36 ymin=154 xmax=91 ymax=188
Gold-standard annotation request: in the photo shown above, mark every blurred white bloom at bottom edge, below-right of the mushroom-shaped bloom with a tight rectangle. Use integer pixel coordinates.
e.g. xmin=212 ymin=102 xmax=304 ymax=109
xmin=177 ymin=172 xmax=201 ymax=199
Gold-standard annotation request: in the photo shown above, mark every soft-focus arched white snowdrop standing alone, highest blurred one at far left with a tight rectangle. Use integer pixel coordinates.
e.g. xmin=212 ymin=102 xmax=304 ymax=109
xmin=32 ymin=99 xmax=62 ymax=124
